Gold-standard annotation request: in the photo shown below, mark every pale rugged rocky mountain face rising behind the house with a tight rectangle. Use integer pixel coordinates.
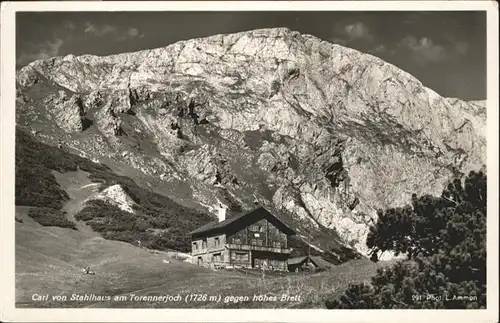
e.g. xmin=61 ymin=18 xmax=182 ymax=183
xmin=17 ymin=29 xmax=486 ymax=253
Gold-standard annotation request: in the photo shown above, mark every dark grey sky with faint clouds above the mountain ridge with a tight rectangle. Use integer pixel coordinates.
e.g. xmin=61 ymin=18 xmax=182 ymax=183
xmin=16 ymin=11 xmax=486 ymax=100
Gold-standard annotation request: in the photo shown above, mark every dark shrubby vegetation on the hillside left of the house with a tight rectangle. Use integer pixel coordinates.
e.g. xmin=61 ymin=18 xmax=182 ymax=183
xmin=16 ymin=130 xmax=211 ymax=251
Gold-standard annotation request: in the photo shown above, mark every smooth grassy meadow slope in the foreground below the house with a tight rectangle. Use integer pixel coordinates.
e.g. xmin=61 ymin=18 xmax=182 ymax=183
xmin=16 ymin=207 xmax=390 ymax=308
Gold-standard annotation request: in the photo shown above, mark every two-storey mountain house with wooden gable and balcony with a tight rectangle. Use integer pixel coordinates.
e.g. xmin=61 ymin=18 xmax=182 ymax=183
xmin=191 ymin=207 xmax=295 ymax=271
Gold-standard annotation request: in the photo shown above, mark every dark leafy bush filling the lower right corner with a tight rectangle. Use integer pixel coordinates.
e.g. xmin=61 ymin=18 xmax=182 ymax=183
xmin=325 ymin=172 xmax=487 ymax=309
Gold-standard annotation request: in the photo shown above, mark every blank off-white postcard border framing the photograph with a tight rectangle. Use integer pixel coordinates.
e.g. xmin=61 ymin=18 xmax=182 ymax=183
xmin=0 ymin=1 xmax=499 ymax=322
